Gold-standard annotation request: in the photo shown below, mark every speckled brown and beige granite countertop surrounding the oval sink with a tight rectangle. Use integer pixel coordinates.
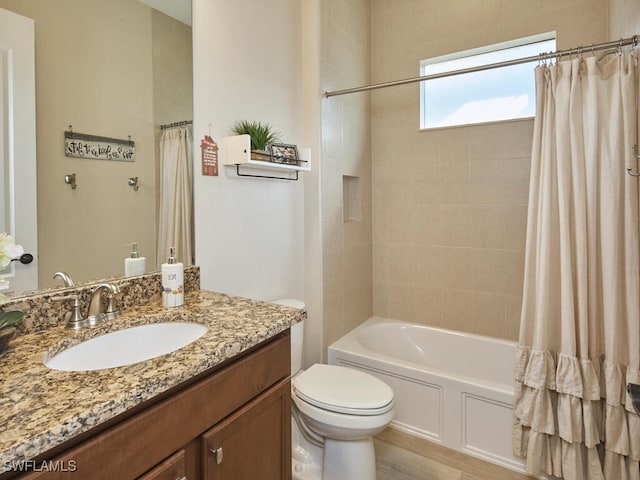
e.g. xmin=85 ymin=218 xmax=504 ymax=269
xmin=0 ymin=290 xmax=306 ymax=473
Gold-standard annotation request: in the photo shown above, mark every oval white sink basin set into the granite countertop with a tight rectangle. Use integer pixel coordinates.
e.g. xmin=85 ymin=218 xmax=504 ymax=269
xmin=44 ymin=322 xmax=207 ymax=372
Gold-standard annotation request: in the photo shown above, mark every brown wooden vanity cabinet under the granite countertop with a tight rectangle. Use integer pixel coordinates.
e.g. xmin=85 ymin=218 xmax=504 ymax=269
xmin=15 ymin=331 xmax=291 ymax=480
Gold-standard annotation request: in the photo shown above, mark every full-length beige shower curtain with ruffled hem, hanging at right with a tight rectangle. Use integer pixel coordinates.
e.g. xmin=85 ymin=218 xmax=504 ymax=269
xmin=513 ymin=52 xmax=640 ymax=480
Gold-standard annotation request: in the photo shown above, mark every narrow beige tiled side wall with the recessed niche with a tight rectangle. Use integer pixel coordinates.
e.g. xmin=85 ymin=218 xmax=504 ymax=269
xmin=321 ymin=0 xmax=373 ymax=355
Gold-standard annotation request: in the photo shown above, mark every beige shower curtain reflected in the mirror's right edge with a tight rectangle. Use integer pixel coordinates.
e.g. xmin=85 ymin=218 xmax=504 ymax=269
xmin=157 ymin=127 xmax=193 ymax=268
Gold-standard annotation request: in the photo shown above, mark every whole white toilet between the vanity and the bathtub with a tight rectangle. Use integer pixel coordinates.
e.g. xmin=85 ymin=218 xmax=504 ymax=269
xmin=275 ymin=299 xmax=394 ymax=480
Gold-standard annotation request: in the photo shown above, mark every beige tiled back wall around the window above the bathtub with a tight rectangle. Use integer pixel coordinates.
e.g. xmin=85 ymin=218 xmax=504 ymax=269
xmin=371 ymin=0 xmax=608 ymax=339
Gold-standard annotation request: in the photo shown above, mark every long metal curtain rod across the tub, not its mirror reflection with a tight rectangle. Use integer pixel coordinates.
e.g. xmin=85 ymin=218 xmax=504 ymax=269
xmin=324 ymin=35 xmax=638 ymax=98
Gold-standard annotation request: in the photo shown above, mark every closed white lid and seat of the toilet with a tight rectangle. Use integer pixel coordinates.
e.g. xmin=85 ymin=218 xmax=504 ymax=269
xmin=293 ymin=363 xmax=393 ymax=415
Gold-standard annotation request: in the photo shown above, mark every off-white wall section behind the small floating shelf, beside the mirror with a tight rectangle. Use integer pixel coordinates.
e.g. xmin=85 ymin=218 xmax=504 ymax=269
xmin=193 ymin=0 xmax=304 ymax=300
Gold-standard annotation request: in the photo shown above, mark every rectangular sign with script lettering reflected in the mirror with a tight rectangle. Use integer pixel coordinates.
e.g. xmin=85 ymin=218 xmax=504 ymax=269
xmin=64 ymin=130 xmax=135 ymax=162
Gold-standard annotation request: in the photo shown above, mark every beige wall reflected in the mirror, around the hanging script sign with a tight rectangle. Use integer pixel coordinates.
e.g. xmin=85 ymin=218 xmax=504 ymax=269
xmin=0 ymin=0 xmax=193 ymax=295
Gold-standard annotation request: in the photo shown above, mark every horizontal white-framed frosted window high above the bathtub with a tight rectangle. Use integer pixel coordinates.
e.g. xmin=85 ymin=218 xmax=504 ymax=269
xmin=420 ymin=32 xmax=556 ymax=128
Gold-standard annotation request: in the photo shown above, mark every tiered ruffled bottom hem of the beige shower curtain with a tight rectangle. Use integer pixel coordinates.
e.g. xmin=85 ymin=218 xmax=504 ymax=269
xmin=513 ymin=346 xmax=640 ymax=480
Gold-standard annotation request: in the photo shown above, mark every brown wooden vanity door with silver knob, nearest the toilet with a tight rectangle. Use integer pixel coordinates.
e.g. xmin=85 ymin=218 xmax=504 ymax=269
xmin=202 ymin=379 xmax=291 ymax=480
